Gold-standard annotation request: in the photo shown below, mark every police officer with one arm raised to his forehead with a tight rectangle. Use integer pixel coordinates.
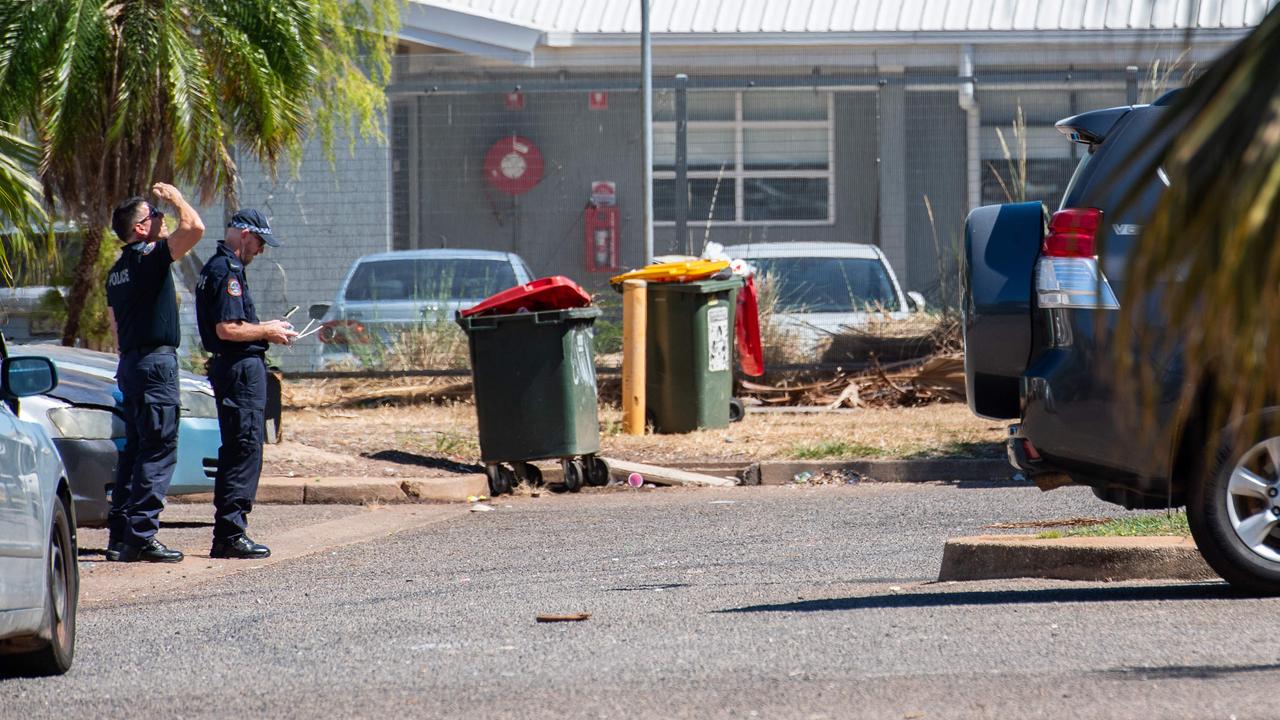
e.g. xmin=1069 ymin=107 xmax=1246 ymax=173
xmin=106 ymin=182 xmax=205 ymax=562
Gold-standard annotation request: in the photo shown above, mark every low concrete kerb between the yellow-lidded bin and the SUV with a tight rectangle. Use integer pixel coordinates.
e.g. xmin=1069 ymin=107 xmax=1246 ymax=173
xmin=742 ymin=457 xmax=1014 ymax=486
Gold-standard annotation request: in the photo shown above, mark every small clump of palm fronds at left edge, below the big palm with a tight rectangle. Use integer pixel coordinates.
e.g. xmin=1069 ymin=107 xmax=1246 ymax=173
xmin=0 ymin=126 xmax=52 ymax=283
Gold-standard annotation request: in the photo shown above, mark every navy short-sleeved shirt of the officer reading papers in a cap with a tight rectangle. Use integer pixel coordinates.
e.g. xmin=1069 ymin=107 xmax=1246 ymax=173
xmin=196 ymin=242 xmax=266 ymax=355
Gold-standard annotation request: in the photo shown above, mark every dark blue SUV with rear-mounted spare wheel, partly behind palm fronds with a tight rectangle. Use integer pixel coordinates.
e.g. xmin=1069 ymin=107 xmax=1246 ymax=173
xmin=963 ymin=94 xmax=1280 ymax=593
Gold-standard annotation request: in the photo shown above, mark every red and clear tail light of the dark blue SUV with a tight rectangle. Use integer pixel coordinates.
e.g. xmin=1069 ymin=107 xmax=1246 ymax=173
xmin=1036 ymin=208 xmax=1120 ymax=310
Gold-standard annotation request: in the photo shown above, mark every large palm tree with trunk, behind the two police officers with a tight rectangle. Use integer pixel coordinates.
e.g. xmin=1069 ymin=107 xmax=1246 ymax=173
xmin=0 ymin=0 xmax=398 ymax=345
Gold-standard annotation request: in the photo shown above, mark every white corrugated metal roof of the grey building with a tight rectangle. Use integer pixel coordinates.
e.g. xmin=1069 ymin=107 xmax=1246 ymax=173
xmin=411 ymin=0 xmax=1280 ymax=35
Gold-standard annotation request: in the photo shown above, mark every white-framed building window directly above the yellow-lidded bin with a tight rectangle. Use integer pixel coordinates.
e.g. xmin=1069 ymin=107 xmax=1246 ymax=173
xmin=653 ymin=90 xmax=835 ymax=225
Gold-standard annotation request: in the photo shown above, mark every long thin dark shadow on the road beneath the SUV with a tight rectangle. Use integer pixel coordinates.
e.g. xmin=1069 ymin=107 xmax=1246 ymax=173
xmin=717 ymin=582 xmax=1248 ymax=612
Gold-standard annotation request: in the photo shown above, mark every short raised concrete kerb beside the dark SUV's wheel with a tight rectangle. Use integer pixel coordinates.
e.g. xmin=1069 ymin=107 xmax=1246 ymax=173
xmin=938 ymin=536 xmax=1217 ymax=582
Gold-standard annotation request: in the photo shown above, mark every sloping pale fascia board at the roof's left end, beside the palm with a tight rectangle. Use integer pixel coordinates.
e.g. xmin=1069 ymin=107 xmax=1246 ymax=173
xmin=397 ymin=3 xmax=544 ymax=65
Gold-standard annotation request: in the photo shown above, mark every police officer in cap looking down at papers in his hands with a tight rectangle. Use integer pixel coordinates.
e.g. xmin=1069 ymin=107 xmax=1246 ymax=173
xmin=196 ymin=209 xmax=297 ymax=559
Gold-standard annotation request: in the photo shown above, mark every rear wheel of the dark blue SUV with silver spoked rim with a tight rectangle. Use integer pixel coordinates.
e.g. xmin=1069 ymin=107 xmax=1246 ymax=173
xmin=1187 ymin=410 xmax=1280 ymax=594
